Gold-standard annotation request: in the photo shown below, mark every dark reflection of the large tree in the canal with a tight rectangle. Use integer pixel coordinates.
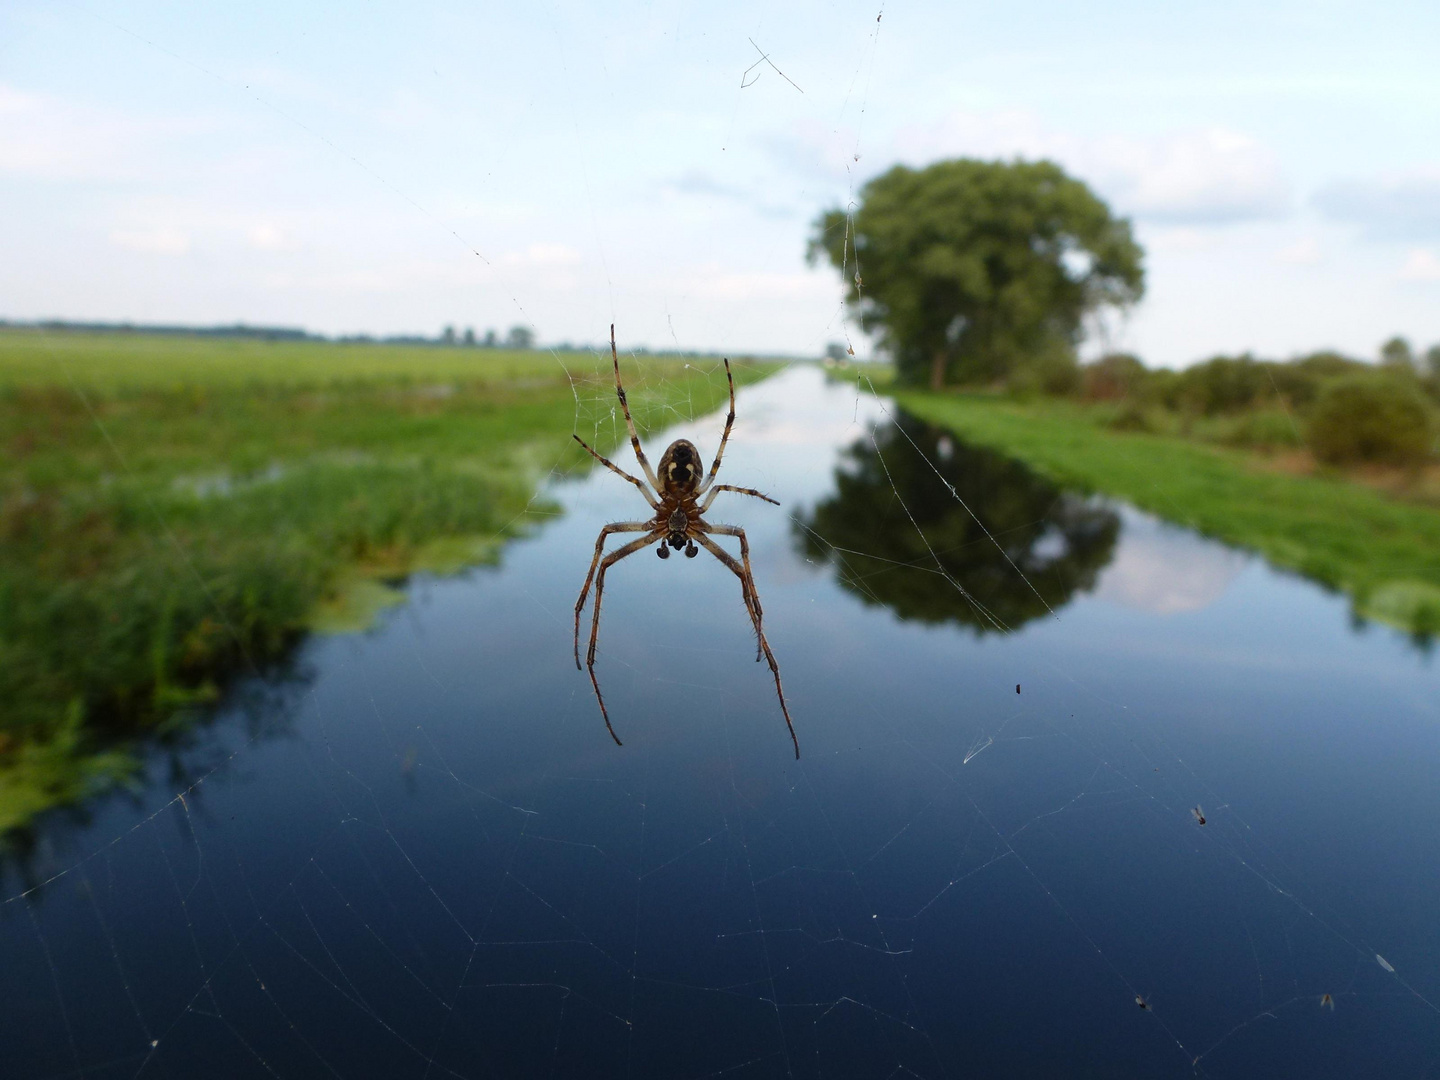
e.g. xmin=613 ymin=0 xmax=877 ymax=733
xmin=796 ymin=413 xmax=1120 ymax=634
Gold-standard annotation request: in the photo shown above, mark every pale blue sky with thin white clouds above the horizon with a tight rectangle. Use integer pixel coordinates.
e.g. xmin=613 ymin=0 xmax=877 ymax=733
xmin=0 ymin=0 xmax=1440 ymax=366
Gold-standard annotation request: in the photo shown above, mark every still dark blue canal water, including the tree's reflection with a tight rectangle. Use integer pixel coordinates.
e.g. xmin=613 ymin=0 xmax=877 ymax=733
xmin=0 ymin=369 xmax=1440 ymax=1077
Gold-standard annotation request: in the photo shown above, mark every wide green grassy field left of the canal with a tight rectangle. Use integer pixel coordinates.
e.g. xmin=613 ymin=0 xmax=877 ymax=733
xmin=0 ymin=330 xmax=768 ymax=832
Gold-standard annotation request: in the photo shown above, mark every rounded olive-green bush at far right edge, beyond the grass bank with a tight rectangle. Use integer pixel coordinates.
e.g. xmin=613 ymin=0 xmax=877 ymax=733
xmin=1309 ymin=376 xmax=1434 ymax=465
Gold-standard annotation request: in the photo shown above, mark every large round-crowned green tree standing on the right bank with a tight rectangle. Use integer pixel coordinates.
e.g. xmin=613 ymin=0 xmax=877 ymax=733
xmin=809 ymin=158 xmax=1145 ymax=387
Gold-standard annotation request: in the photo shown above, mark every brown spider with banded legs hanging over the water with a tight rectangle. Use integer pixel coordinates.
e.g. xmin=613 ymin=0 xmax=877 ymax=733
xmin=573 ymin=323 xmax=801 ymax=760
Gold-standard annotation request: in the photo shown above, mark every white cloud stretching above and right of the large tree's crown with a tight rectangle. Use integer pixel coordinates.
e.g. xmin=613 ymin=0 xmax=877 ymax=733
xmin=896 ymin=111 xmax=1292 ymax=225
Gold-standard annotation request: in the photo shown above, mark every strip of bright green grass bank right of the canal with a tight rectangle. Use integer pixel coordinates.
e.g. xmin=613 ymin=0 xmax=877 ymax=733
xmin=896 ymin=392 xmax=1440 ymax=634
